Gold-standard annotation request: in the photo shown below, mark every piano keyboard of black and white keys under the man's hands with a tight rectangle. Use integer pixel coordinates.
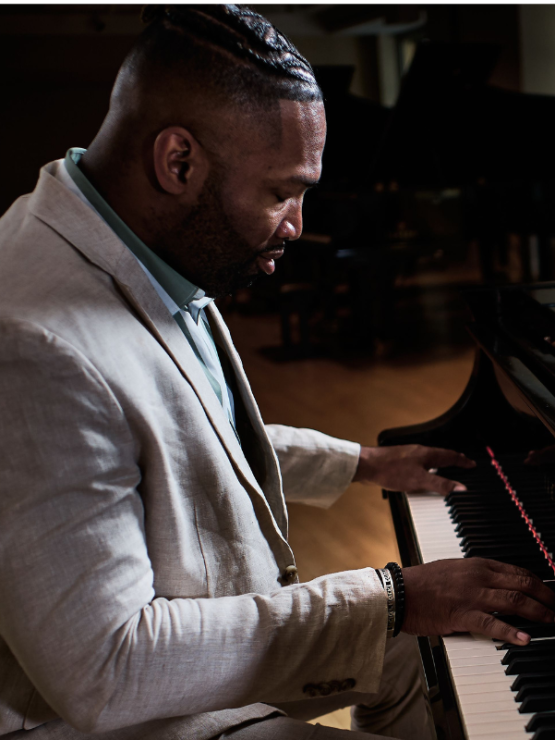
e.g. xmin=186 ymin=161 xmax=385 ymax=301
xmin=406 ymin=455 xmax=555 ymax=740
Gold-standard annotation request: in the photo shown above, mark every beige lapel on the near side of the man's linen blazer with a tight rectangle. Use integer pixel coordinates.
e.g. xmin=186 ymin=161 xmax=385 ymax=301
xmin=29 ymin=162 xmax=284 ymax=534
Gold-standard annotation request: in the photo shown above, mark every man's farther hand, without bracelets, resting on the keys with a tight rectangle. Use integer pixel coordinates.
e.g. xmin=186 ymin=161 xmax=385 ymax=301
xmin=353 ymin=445 xmax=476 ymax=496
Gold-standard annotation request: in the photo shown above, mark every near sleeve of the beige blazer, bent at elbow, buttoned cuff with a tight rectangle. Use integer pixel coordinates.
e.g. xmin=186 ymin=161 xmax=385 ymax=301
xmin=0 ymin=321 xmax=386 ymax=732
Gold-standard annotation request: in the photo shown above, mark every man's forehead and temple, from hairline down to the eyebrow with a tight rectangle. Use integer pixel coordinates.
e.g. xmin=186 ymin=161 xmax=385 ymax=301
xmin=230 ymin=100 xmax=326 ymax=179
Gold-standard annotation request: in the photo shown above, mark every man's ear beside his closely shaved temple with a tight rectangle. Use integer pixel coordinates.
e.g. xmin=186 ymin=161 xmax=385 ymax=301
xmin=153 ymin=126 xmax=209 ymax=199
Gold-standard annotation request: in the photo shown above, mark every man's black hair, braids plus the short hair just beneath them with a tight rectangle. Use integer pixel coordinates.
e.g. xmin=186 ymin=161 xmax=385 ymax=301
xmin=132 ymin=5 xmax=322 ymax=104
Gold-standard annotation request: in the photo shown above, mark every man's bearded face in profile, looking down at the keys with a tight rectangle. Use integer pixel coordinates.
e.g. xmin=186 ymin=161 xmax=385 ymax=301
xmin=153 ymin=100 xmax=326 ymax=297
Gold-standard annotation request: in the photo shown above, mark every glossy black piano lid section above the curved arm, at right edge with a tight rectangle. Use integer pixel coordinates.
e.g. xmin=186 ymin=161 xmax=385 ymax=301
xmin=464 ymin=283 xmax=555 ymax=436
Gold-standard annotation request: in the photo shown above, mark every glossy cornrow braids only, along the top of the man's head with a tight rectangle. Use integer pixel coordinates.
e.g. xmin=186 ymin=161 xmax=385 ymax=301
xmin=141 ymin=5 xmax=315 ymax=85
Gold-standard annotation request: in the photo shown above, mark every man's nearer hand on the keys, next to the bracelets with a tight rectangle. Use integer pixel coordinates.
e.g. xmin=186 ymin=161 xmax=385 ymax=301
xmin=402 ymin=558 xmax=555 ymax=645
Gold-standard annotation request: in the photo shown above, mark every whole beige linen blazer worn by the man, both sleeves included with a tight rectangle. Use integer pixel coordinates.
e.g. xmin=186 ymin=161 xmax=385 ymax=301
xmin=0 ymin=161 xmax=386 ymax=740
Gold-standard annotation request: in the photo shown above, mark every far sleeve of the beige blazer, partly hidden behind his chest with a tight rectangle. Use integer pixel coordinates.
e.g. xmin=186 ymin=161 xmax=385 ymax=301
xmin=266 ymin=424 xmax=360 ymax=508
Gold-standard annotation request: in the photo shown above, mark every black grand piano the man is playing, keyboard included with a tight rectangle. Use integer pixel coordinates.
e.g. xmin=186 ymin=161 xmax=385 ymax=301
xmin=379 ymin=283 xmax=555 ymax=740
